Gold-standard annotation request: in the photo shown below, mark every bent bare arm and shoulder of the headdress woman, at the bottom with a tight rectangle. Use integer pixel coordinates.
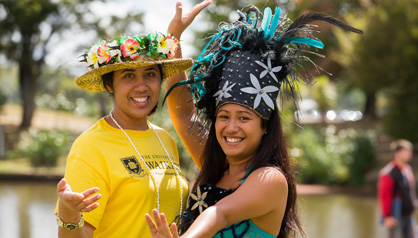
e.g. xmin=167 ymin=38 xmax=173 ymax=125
xmin=182 ymin=168 xmax=288 ymax=238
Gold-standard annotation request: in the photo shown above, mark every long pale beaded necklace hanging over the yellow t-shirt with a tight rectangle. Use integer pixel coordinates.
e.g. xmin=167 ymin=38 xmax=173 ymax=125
xmin=109 ymin=111 xmax=183 ymax=215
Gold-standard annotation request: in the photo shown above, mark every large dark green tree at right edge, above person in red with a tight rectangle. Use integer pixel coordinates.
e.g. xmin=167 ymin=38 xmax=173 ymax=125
xmin=336 ymin=0 xmax=418 ymax=142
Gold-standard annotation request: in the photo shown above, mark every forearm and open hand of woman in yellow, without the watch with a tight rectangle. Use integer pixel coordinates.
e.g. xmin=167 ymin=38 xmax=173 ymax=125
xmin=57 ymin=179 xmax=101 ymax=238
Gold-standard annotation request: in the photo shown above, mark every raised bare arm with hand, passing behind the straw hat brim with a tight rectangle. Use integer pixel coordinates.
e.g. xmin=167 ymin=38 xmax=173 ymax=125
xmin=166 ymin=0 xmax=212 ymax=167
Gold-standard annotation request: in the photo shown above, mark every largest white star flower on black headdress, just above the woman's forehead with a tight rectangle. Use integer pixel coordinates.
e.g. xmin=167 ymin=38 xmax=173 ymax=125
xmin=241 ymin=74 xmax=279 ymax=109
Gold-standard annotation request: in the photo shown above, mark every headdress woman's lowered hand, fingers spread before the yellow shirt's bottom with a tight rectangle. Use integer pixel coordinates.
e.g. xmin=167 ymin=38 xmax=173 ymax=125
xmin=145 ymin=209 xmax=179 ymax=238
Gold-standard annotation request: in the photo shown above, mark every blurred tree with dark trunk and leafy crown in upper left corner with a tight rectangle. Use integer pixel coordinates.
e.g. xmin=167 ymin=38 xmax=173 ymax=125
xmin=0 ymin=0 xmax=142 ymax=129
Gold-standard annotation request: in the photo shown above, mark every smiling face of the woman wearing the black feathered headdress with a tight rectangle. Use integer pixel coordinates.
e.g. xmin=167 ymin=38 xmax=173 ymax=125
xmin=215 ymin=103 xmax=265 ymax=160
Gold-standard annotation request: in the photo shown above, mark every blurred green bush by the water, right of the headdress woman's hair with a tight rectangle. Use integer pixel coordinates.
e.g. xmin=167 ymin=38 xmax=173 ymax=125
xmin=290 ymin=126 xmax=375 ymax=185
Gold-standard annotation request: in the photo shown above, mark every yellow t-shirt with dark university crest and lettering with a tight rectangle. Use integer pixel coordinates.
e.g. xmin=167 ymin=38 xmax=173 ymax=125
xmin=57 ymin=118 xmax=188 ymax=238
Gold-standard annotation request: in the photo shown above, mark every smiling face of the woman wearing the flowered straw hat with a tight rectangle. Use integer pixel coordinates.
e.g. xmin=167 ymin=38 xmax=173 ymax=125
xmin=107 ymin=65 xmax=161 ymax=129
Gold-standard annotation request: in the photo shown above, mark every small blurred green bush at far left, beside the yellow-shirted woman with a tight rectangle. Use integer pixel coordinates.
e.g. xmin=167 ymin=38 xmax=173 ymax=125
xmin=19 ymin=129 xmax=73 ymax=167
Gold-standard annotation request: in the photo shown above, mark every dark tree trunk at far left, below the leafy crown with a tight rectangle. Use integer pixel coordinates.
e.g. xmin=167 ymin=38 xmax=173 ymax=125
xmin=19 ymin=43 xmax=38 ymax=130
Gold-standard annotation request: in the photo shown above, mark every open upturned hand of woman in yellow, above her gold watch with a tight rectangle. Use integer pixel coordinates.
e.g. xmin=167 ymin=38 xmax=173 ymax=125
xmin=57 ymin=178 xmax=102 ymax=214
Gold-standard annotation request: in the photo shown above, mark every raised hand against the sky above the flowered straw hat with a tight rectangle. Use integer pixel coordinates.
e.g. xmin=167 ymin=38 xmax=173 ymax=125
xmin=167 ymin=0 xmax=212 ymax=39
